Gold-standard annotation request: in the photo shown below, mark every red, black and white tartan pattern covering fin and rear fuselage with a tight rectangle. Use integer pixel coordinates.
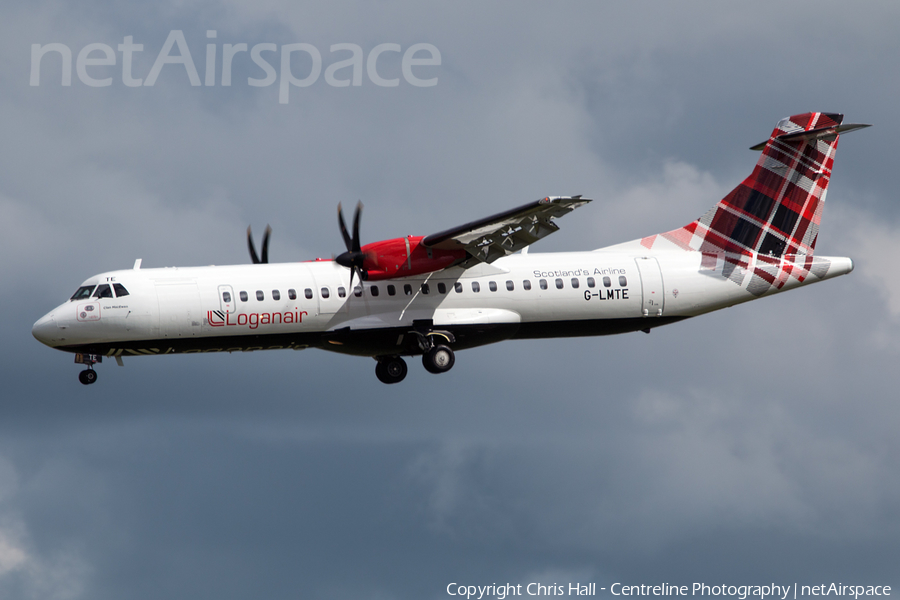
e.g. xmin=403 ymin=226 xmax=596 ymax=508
xmin=641 ymin=113 xmax=844 ymax=296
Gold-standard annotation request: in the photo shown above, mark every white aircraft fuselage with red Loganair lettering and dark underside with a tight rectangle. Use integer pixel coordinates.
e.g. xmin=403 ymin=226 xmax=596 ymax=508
xmin=33 ymin=243 xmax=853 ymax=356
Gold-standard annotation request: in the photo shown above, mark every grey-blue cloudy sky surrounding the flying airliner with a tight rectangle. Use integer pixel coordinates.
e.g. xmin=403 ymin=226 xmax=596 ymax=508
xmin=0 ymin=0 xmax=900 ymax=600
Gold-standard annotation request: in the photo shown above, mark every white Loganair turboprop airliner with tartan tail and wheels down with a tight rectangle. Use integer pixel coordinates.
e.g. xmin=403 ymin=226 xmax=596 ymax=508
xmin=32 ymin=113 xmax=868 ymax=384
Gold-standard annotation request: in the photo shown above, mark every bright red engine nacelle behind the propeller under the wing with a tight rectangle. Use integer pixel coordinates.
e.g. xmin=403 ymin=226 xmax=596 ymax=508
xmin=360 ymin=236 xmax=467 ymax=281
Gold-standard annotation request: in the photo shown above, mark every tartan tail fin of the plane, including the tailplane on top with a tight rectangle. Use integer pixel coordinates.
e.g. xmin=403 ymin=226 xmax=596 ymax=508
xmin=662 ymin=113 xmax=868 ymax=256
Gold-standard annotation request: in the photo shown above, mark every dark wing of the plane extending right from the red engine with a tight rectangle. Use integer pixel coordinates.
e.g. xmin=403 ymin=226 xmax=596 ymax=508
xmin=422 ymin=195 xmax=591 ymax=265
